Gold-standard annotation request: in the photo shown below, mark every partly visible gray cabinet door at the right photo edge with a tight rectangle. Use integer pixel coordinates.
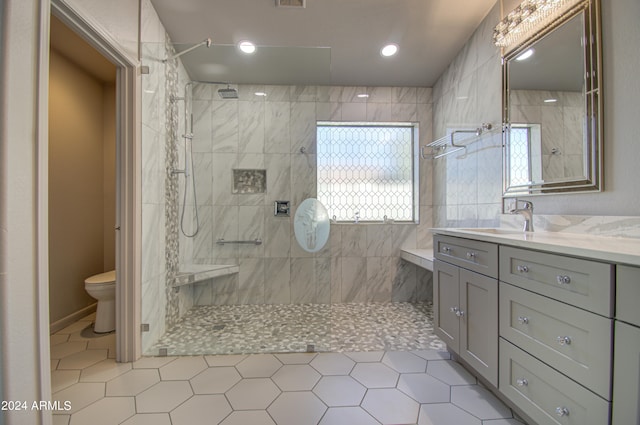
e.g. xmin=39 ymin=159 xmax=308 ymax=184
xmin=613 ymin=321 xmax=640 ymax=425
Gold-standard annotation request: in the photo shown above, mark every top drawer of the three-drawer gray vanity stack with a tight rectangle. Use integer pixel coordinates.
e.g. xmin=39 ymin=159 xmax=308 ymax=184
xmin=500 ymin=246 xmax=614 ymax=317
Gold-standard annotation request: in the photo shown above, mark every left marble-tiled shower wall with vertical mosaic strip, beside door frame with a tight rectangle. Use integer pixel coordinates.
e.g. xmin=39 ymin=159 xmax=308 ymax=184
xmin=141 ymin=0 xmax=188 ymax=351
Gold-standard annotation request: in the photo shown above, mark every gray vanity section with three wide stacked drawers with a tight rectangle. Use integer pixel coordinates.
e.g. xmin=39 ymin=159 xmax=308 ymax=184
xmin=499 ymin=246 xmax=614 ymax=425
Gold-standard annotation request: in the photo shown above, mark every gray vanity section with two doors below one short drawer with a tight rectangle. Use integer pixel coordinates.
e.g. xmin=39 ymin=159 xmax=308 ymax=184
xmin=433 ymin=235 xmax=498 ymax=386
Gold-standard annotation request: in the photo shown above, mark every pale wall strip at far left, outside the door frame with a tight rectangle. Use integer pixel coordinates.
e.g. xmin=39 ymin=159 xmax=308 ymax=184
xmin=0 ymin=0 xmax=50 ymax=425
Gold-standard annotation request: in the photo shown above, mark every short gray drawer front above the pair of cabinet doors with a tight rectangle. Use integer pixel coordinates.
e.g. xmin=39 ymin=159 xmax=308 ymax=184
xmin=433 ymin=235 xmax=498 ymax=278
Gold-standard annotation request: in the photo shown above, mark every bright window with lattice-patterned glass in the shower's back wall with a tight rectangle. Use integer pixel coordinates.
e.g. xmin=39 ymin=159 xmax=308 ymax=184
xmin=317 ymin=122 xmax=418 ymax=222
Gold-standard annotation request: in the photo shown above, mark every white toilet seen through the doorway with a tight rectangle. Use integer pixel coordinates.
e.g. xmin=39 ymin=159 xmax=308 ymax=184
xmin=84 ymin=270 xmax=116 ymax=333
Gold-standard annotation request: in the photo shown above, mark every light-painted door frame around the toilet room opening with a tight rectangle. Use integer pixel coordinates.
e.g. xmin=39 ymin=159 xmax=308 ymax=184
xmin=38 ymin=0 xmax=141 ymax=362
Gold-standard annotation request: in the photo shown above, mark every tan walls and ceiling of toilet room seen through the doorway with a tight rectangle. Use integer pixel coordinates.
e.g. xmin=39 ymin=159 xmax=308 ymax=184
xmin=48 ymin=16 xmax=116 ymax=333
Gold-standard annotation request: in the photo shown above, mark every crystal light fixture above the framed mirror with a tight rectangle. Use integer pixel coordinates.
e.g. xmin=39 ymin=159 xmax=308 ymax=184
xmin=493 ymin=0 xmax=588 ymax=47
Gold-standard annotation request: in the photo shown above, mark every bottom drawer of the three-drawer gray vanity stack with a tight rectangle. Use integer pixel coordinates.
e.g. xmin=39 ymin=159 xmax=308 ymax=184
xmin=499 ymin=338 xmax=611 ymax=425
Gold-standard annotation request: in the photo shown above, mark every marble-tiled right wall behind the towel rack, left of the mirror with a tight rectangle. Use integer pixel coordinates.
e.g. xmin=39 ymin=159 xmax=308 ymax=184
xmin=432 ymin=2 xmax=502 ymax=227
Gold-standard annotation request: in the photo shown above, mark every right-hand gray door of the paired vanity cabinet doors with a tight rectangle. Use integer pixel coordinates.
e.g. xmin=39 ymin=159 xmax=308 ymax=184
xmin=459 ymin=269 xmax=498 ymax=387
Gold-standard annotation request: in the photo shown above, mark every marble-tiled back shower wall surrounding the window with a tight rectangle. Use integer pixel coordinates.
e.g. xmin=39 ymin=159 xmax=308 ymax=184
xmin=181 ymin=84 xmax=432 ymax=306
